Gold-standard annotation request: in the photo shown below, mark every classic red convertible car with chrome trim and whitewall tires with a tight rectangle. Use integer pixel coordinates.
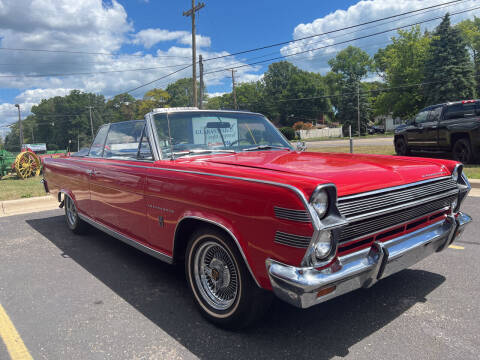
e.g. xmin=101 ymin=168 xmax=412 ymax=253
xmin=44 ymin=108 xmax=471 ymax=328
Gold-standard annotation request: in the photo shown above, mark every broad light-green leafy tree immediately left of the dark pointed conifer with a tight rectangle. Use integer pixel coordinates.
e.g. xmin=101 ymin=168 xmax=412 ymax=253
xmin=374 ymin=26 xmax=431 ymax=117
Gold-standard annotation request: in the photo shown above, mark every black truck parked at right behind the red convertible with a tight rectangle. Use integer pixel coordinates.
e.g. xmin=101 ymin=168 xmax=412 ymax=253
xmin=394 ymin=100 xmax=480 ymax=163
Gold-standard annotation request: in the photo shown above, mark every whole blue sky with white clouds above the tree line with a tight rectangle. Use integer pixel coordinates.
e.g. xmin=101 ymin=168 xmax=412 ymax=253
xmin=0 ymin=0 xmax=480 ymax=130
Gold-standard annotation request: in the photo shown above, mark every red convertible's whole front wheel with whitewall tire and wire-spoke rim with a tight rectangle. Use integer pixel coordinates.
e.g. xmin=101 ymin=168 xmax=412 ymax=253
xmin=185 ymin=227 xmax=270 ymax=329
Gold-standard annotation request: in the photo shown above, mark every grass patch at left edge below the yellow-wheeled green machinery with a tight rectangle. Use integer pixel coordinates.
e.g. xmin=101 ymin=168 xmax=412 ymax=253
xmin=0 ymin=175 xmax=47 ymax=201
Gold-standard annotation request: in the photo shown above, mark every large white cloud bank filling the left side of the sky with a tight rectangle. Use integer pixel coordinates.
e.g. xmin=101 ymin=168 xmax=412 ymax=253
xmin=0 ymin=0 xmax=266 ymax=117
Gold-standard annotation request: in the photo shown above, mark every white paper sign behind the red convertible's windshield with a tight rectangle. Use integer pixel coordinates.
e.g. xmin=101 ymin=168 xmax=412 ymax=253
xmin=192 ymin=117 xmax=238 ymax=148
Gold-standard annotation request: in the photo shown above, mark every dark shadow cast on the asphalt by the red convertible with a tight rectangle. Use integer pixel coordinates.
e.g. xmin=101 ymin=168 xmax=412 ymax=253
xmin=27 ymin=216 xmax=445 ymax=359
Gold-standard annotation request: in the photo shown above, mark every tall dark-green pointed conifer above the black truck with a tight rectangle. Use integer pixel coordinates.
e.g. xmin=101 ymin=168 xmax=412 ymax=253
xmin=424 ymin=14 xmax=474 ymax=104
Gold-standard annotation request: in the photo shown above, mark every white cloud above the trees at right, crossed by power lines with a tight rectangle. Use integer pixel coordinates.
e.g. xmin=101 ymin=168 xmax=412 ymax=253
xmin=281 ymin=0 xmax=478 ymax=73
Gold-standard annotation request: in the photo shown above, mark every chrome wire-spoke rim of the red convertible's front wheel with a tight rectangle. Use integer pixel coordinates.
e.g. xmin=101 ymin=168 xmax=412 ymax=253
xmin=193 ymin=241 xmax=239 ymax=310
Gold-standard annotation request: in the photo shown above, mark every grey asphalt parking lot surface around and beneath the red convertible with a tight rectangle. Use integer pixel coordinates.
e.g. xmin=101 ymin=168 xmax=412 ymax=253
xmin=0 ymin=197 xmax=480 ymax=360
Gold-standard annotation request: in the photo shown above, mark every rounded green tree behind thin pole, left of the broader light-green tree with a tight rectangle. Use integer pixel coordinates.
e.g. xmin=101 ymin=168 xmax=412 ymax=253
xmin=328 ymin=46 xmax=372 ymax=133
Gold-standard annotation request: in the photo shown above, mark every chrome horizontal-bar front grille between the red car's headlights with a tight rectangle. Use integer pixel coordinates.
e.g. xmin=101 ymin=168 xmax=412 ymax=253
xmin=338 ymin=177 xmax=458 ymax=243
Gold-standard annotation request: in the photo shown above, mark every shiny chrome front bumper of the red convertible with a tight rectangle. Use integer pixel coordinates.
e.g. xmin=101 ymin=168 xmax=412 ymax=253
xmin=266 ymin=213 xmax=472 ymax=308
